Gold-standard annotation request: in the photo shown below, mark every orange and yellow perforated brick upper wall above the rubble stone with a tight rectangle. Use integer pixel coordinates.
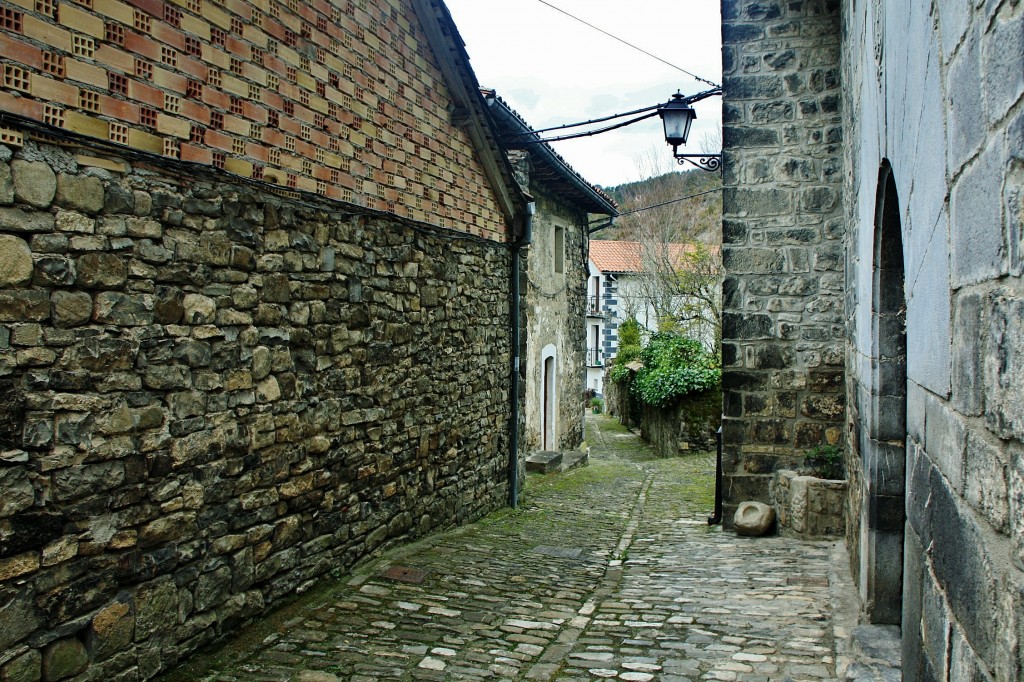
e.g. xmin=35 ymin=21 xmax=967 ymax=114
xmin=0 ymin=0 xmax=507 ymax=241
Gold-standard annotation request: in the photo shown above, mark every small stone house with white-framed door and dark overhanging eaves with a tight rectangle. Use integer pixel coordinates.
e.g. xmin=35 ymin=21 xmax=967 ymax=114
xmin=484 ymin=91 xmax=617 ymax=453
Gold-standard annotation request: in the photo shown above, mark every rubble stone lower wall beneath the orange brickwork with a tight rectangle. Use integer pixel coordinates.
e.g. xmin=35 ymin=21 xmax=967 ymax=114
xmin=0 ymin=135 xmax=510 ymax=680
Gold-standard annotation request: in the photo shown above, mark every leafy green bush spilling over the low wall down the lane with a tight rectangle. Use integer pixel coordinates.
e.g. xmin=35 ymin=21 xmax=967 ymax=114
xmin=631 ymin=333 xmax=722 ymax=408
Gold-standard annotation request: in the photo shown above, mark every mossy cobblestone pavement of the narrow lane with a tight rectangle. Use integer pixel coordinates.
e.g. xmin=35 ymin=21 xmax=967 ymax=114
xmin=161 ymin=418 xmax=872 ymax=682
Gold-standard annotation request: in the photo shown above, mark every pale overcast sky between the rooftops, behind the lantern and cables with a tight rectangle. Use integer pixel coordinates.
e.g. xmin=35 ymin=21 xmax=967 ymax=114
xmin=445 ymin=0 xmax=722 ymax=186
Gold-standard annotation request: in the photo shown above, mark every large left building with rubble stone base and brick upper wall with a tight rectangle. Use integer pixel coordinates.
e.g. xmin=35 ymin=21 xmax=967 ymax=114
xmin=0 ymin=0 xmax=540 ymax=680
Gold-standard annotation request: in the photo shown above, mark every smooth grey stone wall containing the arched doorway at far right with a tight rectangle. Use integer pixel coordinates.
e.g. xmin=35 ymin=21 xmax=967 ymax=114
xmin=843 ymin=0 xmax=1024 ymax=680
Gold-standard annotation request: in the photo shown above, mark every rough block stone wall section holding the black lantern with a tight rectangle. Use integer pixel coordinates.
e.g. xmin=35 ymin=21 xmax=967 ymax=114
xmin=722 ymin=0 xmax=845 ymax=519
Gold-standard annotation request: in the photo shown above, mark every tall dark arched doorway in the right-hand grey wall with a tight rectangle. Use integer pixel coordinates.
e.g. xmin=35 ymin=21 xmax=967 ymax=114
xmin=860 ymin=161 xmax=906 ymax=625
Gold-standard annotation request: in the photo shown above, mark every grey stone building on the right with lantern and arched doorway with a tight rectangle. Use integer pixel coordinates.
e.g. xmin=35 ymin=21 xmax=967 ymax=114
xmin=722 ymin=0 xmax=1024 ymax=680
